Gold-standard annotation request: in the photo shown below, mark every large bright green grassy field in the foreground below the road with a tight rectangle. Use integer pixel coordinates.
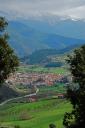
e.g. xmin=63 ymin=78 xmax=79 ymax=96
xmin=0 ymin=99 xmax=71 ymax=128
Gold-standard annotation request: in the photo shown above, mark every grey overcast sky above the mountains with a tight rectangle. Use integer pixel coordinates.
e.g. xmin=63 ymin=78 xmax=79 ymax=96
xmin=0 ymin=0 xmax=85 ymax=18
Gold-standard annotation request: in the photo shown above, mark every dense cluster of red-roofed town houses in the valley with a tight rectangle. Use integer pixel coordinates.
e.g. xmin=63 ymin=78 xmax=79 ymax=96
xmin=7 ymin=73 xmax=63 ymax=86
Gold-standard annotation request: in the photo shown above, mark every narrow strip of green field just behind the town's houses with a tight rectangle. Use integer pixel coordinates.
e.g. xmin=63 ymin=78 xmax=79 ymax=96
xmin=18 ymin=65 xmax=68 ymax=75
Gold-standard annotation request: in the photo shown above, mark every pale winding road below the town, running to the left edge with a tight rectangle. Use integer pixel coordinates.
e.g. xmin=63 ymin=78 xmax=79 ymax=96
xmin=0 ymin=88 xmax=39 ymax=106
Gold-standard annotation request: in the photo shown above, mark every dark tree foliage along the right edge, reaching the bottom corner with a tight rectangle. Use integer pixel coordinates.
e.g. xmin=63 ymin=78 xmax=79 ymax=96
xmin=63 ymin=45 xmax=85 ymax=128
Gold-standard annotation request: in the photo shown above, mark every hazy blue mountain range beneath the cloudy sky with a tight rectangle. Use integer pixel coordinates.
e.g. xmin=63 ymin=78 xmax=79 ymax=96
xmin=7 ymin=19 xmax=85 ymax=57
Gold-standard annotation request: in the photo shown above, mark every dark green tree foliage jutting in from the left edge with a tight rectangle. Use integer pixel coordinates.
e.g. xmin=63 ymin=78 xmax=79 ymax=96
xmin=0 ymin=17 xmax=19 ymax=84
